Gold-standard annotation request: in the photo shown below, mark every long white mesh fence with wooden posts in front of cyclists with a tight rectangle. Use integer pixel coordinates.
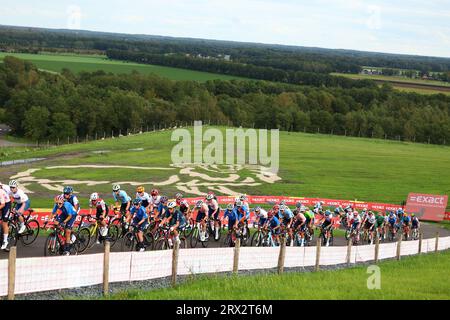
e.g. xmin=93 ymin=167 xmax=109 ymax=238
xmin=0 ymin=235 xmax=450 ymax=299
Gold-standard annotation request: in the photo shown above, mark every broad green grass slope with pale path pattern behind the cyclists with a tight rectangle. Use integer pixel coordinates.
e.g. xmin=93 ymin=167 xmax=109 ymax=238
xmin=0 ymin=128 xmax=450 ymax=208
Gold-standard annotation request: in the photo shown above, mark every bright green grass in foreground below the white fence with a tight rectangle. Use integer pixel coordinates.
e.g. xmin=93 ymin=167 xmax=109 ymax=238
xmin=97 ymin=251 xmax=450 ymax=300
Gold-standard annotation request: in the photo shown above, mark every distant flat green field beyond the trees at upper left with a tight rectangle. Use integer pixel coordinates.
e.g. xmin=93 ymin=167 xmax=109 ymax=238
xmin=0 ymin=52 xmax=248 ymax=82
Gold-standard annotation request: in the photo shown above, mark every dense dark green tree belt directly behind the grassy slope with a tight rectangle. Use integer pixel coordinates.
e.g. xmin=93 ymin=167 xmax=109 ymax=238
xmin=0 ymin=57 xmax=450 ymax=144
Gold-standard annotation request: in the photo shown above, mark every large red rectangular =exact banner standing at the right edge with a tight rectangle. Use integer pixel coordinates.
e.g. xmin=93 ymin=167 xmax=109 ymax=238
xmin=406 ymin=193 xmax=448 ymax=221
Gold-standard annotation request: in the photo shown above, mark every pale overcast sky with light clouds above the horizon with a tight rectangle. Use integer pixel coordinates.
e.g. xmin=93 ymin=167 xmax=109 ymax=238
xmin=0 ymin=0 xmax=450 ymax=57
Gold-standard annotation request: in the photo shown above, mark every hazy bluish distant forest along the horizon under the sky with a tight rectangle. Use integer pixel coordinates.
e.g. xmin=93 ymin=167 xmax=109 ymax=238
xmin=0 ymin=26 xmax=450 ymax=73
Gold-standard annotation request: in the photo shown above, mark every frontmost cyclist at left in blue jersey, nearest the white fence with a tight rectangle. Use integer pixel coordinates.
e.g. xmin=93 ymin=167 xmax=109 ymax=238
xmin=52 ymin=195 xmax=77 ymax=256
